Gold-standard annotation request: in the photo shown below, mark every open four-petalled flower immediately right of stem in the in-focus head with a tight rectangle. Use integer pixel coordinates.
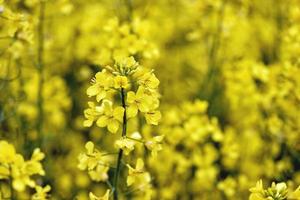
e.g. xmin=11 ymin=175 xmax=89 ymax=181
xmin=127 ymin=87 xmax=152 ymax=118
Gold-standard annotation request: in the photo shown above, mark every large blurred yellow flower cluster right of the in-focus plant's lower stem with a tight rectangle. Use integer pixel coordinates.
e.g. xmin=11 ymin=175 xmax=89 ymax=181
xmin=149 ymin=100 xmax=224 ymax=199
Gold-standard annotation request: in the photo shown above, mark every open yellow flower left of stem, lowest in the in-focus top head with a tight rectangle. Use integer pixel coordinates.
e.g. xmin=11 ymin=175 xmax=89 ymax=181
xmin=97 ymin=101 xmax=125 ymax=133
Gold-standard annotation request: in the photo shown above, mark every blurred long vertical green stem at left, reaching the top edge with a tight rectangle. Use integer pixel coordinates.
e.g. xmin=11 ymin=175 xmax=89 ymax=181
xmin=36 ymin=0 xmax=45 ymax=146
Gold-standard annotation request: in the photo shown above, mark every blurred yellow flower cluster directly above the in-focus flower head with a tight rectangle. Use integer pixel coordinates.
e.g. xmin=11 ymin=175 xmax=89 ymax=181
xmin=92 ymin=17 xmax=159 ymax=65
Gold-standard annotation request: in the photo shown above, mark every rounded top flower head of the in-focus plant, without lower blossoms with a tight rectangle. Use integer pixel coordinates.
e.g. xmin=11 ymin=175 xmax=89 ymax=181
xmin=84 ymin=57 xmax=161 ymax=133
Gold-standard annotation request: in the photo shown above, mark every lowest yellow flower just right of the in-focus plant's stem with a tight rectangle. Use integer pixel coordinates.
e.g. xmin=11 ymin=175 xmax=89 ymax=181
xmin=127 ymin=158 xmax=151 ymax=186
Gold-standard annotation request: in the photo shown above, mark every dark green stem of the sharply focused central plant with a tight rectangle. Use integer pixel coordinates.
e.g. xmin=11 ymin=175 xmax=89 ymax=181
xmin=112 ymin=88 xmax=127 ymax=200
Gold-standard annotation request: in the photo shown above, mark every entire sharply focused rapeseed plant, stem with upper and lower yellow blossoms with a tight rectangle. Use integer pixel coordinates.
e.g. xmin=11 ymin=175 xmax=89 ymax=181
xmin=78 ymin=57 xmax=163 ymax=199
